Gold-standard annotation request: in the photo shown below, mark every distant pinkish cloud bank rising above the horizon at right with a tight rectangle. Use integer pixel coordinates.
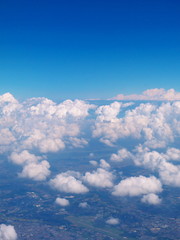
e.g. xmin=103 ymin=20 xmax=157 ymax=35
xmin=111 ymin=88 xmax=180 ymax=101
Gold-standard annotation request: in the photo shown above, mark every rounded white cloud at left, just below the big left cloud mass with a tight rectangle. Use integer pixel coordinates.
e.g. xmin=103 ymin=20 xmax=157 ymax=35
xmin=19 ymin=160 xmax=50 ymax=181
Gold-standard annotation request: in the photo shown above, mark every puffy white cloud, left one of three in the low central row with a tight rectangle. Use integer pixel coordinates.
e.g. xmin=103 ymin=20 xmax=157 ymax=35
xmin=50 ymin=172 xmax=89 ymax=194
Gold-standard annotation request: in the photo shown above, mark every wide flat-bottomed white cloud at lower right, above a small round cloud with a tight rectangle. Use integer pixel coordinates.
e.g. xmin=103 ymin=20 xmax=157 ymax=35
xmin=112 ymin=176 xmax=162 ymax=196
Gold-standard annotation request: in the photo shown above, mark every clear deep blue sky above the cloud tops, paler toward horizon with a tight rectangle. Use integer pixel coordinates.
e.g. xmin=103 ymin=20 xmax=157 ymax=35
xmin=0 ymin=0 xmax=180 ymax=99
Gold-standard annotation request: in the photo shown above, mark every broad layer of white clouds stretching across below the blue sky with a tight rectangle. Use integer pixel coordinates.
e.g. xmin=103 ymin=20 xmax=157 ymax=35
xmin=0 ymin=92 xmax=180 ymax=207
